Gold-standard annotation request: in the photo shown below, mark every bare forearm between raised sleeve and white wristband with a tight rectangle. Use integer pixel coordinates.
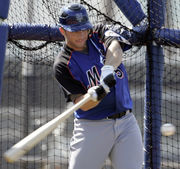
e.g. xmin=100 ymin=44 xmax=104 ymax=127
xmin=105 ymin=40 xmax=123 ymax=69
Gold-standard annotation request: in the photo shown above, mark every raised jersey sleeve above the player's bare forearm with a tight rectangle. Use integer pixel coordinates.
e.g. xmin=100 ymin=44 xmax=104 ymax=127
xmin=93 ymin=24 xmax=132 ymax=51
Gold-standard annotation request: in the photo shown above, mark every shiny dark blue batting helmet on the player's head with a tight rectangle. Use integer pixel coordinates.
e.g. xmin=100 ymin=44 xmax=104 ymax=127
xmin=59 ymin=3 xmax=92 ymax=32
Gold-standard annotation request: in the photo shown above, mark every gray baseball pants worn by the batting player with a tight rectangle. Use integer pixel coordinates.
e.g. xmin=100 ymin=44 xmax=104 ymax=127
xmin=69 ymin=113 xmax=143 ymax=169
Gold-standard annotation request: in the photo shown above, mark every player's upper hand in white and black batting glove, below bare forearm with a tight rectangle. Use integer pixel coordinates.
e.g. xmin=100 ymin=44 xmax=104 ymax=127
xmin=100 ymin=65 xmax=116 ymax=93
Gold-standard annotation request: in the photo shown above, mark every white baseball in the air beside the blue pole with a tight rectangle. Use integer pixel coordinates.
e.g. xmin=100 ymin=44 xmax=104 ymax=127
xmin=161 ymin=123 xmax=176 ymax=136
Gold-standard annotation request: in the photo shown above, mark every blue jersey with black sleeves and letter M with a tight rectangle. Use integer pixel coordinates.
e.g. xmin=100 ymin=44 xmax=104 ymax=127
xmin=54 ymin=25 xmax=132 ymax=120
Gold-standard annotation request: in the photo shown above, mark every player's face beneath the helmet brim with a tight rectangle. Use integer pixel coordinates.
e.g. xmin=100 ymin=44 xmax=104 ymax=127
xmin=61 ymin=30 xmax=89 ymax=51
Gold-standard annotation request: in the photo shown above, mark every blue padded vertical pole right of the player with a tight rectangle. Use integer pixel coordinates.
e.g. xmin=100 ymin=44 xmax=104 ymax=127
xmin=144 ymin=0 xmax=164 ymax=169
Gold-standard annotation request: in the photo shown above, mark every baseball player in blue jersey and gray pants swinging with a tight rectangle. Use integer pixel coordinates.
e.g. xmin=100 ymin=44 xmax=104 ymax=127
xmin=53 ymin=3 xmax=143 ymax=169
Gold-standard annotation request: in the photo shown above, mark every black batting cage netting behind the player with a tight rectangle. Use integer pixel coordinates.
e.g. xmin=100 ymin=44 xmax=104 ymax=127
xmin=0 ymin=0 xmax=180 ymax=169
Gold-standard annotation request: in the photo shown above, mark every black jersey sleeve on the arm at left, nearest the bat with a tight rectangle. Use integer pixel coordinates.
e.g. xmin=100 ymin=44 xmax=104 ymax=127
xmin=53 ymin=52 xmax=87 ymax=101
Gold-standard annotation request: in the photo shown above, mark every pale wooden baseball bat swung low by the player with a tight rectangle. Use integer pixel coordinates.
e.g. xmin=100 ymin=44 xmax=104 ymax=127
xmin=4 ymin=93 xmax=91 ymax=163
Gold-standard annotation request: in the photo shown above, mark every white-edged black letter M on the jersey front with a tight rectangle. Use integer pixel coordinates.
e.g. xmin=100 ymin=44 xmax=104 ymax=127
xmin=86 ymin=66 xmax=100 ymax=88
